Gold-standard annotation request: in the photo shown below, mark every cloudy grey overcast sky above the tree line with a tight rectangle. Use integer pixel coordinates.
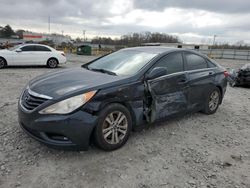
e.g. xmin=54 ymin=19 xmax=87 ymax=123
xmin=0 ymin=0 xmax=250 ymax=43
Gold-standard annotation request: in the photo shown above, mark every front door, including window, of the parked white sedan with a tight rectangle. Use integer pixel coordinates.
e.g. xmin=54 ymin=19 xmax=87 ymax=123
xmin=13 ymin=45 xmax=36 ymax=65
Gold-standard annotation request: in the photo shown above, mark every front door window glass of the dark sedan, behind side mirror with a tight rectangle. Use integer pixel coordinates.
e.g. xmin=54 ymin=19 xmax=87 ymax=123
xmin=155 ymin=53 xmax=183 ymax=74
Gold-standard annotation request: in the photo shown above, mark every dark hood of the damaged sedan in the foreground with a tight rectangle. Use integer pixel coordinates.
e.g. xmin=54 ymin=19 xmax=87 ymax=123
xmin=29 ymin=68 xmax=128 ymax=98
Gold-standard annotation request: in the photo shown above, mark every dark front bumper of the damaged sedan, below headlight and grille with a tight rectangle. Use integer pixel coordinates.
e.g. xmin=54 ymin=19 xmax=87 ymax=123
xmin=18 ymin=104 xmax=97 ymax=150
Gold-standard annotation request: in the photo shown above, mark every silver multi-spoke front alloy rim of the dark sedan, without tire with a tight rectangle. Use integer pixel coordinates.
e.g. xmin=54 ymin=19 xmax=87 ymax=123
xmin=102 ymin=111 xmax=128 ymax=144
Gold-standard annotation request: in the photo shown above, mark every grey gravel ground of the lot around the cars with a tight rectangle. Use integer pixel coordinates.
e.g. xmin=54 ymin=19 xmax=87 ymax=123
xmin=0 ymin=55 xmax=250 ymax=188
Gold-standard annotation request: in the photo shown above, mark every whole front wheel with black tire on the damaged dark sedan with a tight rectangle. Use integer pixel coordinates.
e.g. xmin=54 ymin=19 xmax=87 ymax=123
xmin=93 ymin=103 xmax=132 ymax=151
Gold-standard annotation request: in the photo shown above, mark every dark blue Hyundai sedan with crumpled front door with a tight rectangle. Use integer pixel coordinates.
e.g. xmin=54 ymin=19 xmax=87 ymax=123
xmin=18 ymin=47 xmax=228 ymax=151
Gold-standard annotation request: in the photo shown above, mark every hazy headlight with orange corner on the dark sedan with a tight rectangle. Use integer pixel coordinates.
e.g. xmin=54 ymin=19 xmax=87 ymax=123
xmin=39 ymin=91 xmax=96 ymax=114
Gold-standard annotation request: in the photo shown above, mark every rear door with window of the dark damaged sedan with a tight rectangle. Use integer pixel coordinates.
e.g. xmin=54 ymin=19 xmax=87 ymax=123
xmin=184 ymin=52 xmax=215 ymax=110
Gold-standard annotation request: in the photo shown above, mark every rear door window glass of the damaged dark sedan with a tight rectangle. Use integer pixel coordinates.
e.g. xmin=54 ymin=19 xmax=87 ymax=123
xmin=185 ymin=53 xmax=208 ymax=70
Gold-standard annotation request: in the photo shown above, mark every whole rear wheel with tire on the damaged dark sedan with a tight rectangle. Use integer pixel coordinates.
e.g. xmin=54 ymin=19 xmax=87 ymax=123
xmin=203 ymin=87 xmax=221 ymax=115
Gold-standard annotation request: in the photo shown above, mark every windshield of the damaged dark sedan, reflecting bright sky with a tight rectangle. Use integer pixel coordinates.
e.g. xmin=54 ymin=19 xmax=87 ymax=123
xmin=85 ymin=50 xmax=157 ymax=76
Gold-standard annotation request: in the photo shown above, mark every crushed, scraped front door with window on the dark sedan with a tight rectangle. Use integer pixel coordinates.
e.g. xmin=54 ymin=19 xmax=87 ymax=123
xmin=146 ymin=52 xmax=188 ymax=122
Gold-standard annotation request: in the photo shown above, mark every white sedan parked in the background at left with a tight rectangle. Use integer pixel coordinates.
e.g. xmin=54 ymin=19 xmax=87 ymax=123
xmin=0 ymin=44 xmax=67 ymax=69
